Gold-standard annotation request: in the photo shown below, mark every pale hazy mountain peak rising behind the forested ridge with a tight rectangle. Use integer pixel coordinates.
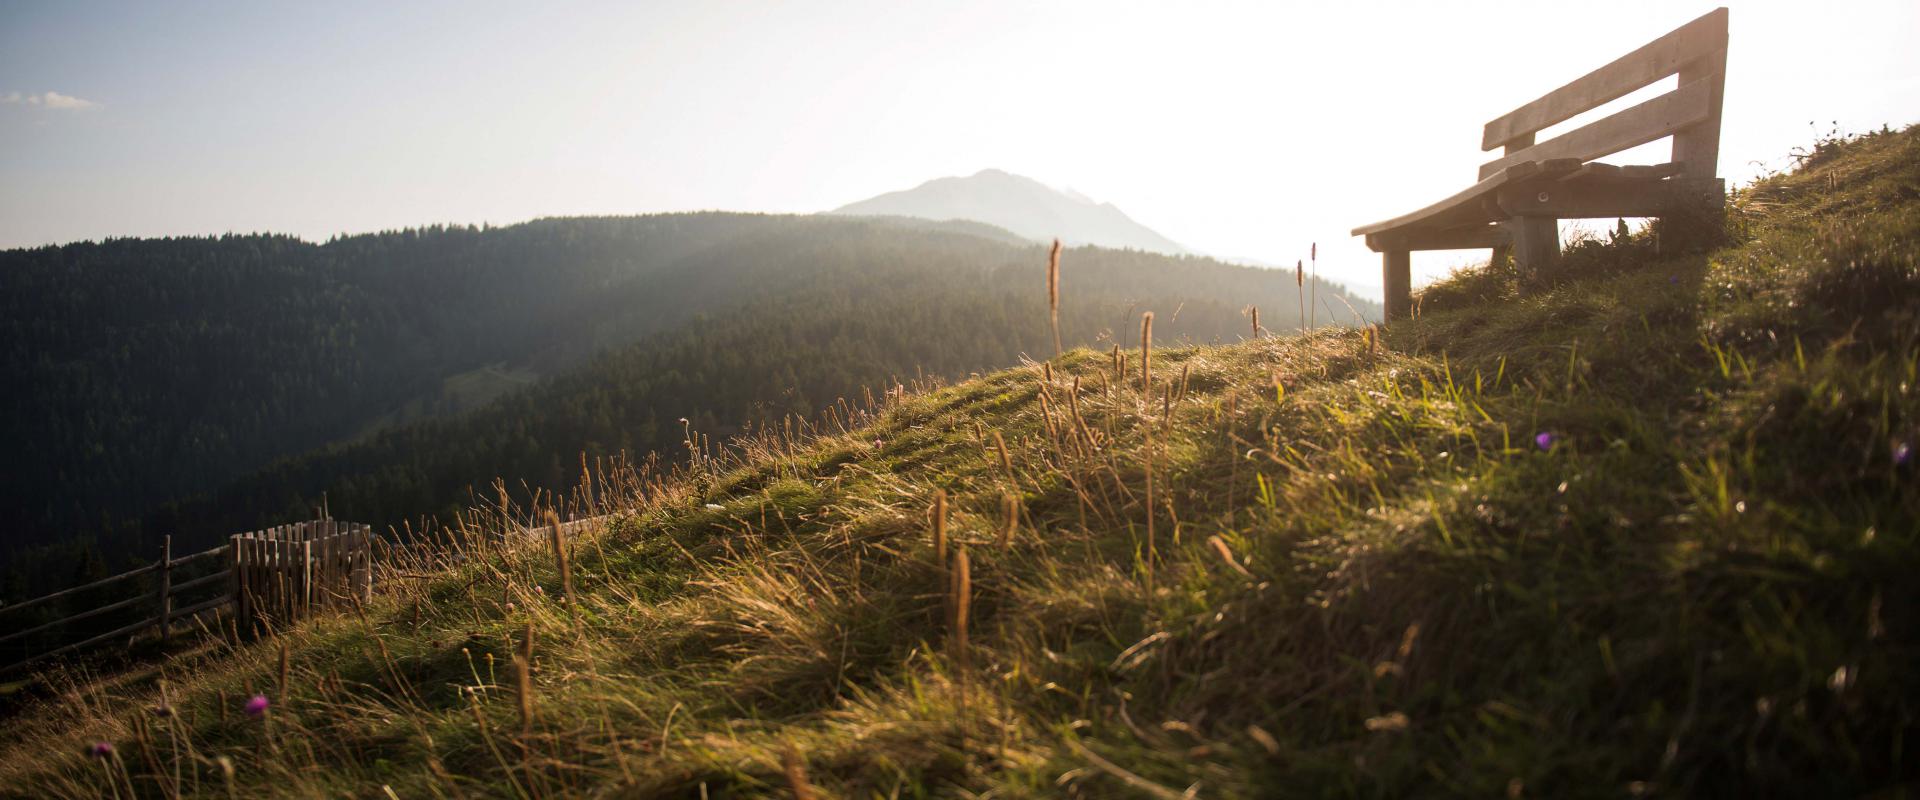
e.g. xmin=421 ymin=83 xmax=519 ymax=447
xmin=828 ymin=167 xmax=1192 ymax=255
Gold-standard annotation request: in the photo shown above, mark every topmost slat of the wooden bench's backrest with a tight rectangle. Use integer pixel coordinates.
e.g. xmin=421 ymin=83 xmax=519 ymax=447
xmin=1480 ymin=8 xmax=1726 ymax=150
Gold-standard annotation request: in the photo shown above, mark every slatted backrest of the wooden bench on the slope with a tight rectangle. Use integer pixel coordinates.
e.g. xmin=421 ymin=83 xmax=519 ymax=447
xmin=1480 ymin=8 xmax=1726 ymax=180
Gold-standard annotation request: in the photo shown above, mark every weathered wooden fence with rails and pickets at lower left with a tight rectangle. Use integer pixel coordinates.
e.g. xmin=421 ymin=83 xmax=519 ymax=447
xmin=0 ymin=520 xmax=372 ymax=671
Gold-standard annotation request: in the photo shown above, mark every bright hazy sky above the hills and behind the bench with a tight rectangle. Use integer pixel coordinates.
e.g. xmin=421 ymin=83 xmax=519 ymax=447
xmin=0 ymin=0 xmax=1920 ymax=293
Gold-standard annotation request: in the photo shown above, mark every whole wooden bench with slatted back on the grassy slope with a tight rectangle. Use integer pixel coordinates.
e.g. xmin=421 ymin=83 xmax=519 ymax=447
xmin=1354 ymin=8 xmax=1726 ymax=318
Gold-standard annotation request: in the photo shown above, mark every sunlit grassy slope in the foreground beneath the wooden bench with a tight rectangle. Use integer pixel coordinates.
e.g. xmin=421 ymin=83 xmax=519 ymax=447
xmin=0 ymin=130 xmax=1920 ymax=798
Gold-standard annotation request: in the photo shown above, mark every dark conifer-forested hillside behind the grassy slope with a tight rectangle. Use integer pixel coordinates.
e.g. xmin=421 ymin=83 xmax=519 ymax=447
xmin=0 ymin=213 xmax=1373 ymax=567
